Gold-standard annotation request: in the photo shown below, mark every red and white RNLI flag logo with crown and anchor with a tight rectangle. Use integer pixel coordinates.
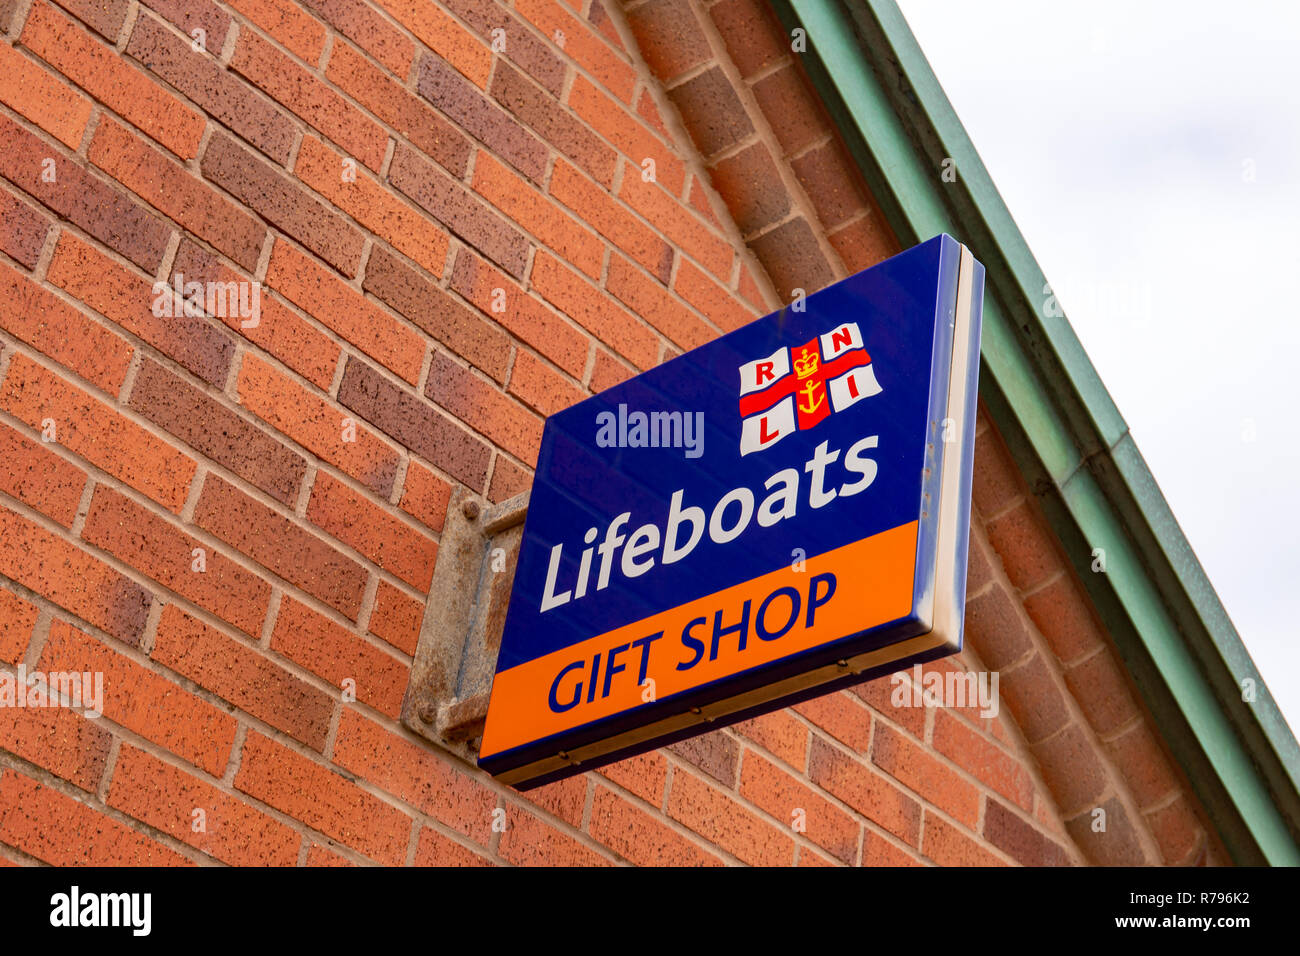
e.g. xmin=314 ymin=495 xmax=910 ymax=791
xmin=740 ymin=323 xmax=880 ymax=455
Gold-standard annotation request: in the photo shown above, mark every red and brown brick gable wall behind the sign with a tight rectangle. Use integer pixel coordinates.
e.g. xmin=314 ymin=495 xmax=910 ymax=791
xmin=0 ymin=0 xmax=1222 ymax=865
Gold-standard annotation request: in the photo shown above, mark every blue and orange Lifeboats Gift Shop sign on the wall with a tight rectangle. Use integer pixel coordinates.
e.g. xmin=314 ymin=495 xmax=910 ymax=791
xmin=478 ymin=235 xmax=984 ymax=788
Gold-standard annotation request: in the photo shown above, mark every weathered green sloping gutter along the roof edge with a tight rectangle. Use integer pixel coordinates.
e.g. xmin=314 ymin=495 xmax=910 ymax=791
xmin=774 ymin=0 xmax=1300 ymax=865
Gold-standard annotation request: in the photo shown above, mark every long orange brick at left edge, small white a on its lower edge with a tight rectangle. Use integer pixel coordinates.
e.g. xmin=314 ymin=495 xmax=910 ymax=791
xmin=0 ymin=355 xmax=198 ymax=512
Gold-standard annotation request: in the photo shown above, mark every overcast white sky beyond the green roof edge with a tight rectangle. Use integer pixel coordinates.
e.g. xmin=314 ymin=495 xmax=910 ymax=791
xmin=898 ymin=0 xmax=1300 ymax=730
